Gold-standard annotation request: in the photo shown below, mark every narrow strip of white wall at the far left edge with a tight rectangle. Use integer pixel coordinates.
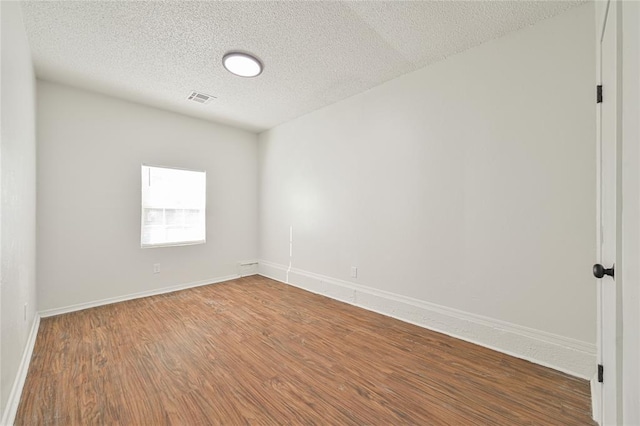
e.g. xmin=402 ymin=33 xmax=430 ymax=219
xmin=0 ymin=2 xmax=36 ymax=422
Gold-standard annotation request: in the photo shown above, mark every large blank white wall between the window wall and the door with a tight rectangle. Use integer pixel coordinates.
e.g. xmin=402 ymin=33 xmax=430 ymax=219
xmin=259 ymin=4 xmax=596 ymax=377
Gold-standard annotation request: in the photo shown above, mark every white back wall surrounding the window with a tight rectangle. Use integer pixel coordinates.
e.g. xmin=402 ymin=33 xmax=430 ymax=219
xmin=37 ymin=81 xmax=257 ymax=311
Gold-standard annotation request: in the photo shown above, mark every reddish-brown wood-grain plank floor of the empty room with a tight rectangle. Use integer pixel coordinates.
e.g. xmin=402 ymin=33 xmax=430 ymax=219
xmin=16 ymin=276 xmax=595 ymax=425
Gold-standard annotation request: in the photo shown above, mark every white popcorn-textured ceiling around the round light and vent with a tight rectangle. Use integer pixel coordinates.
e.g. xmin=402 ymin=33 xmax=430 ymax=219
xmin=23 ymin=0 xmax=581 ymax=131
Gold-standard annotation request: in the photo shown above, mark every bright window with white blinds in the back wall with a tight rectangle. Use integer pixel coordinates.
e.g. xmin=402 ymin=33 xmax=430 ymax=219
xmin=140 ymin=164 xmax=207 ymax=247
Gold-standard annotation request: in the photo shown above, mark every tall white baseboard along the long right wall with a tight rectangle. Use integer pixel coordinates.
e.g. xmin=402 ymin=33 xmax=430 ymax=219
xmin=258 ymin=260 xmax=596 ymax=380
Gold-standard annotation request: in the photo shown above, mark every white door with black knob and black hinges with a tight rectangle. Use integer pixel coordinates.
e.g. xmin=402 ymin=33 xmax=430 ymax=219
xmin=594 ymin=0 xmax=622 ymax=425
